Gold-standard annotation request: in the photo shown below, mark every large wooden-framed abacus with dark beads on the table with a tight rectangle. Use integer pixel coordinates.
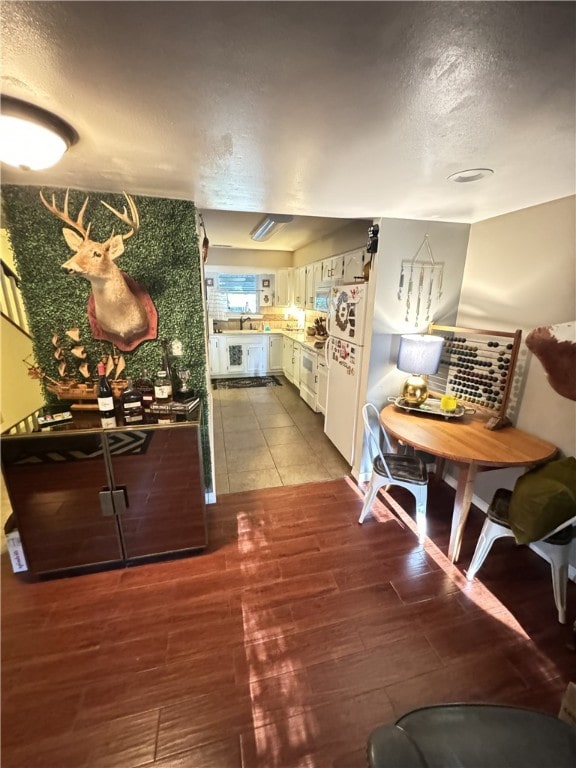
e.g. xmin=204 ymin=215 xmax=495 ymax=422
xmin=428 ymin=324 xmax=522 ymax=419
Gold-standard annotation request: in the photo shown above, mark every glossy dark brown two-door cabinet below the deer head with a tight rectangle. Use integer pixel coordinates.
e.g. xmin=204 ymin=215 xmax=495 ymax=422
xmin=2 ymin=422 xmax=207 ymax=575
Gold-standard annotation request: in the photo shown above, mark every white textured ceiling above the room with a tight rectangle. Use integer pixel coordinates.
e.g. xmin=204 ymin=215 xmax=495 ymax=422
xmin=1 ymin=0 xmax=576 ymax=249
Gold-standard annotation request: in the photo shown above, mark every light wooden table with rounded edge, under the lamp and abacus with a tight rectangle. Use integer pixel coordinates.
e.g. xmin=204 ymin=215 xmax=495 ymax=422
xmin=380 ymin=404 xmax=558 ymax=562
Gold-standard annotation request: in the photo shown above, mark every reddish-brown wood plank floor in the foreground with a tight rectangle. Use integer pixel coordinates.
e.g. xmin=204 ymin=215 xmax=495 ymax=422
xmin=2 ymin=479 xmax=576 ymax=768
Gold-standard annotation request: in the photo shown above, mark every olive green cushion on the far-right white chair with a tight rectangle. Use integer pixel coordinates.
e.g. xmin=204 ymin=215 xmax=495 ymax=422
xmin=508 ymin=457 xmax=576 ymax=544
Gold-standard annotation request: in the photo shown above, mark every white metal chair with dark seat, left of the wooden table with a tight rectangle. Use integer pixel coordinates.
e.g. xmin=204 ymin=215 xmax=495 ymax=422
xmin=358 ymin=403 xmax=428 ymax=542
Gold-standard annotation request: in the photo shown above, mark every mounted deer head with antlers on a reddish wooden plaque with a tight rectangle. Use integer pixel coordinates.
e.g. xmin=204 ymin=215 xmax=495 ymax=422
xmin=40 ymin=190 xmax=157 ymax=352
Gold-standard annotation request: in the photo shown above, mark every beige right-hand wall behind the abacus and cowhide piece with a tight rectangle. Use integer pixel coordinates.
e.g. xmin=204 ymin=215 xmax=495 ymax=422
xmin=458 ymin=197 xmax=576 ymax=503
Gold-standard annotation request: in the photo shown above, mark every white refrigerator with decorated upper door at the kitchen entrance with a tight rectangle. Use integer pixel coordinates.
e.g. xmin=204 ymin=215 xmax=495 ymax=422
xmin=324 ymin=283 xmax=368 ymax=465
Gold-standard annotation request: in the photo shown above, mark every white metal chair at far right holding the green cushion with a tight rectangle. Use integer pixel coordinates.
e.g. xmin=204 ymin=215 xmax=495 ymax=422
xmin=466 ymin=488 xmax=576 ymax=624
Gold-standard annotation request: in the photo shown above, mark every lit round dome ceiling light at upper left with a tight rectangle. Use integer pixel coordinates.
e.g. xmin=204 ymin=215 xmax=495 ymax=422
xmin=0 ymin=96 xmax=78 ymax=171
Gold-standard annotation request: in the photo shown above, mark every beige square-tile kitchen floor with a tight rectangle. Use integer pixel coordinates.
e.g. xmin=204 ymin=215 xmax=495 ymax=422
xmin=213 ymin=376 xmax=350 ymax=495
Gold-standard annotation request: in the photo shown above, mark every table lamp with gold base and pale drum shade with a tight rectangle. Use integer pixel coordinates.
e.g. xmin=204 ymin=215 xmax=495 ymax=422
xmin=396 ymin=333 xmax=444 ymax=406
